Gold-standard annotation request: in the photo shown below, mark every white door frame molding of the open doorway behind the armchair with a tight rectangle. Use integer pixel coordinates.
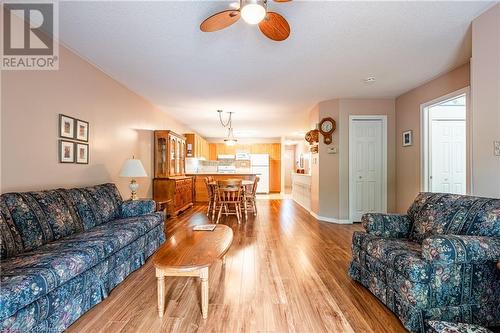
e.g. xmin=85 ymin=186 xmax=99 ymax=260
xmin=420 ymin=86 xmax=473 ymax=193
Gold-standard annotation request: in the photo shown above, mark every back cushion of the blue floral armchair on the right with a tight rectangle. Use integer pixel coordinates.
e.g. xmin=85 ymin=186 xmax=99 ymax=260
xmin=408 ymin=193 xmax=500 ymax=243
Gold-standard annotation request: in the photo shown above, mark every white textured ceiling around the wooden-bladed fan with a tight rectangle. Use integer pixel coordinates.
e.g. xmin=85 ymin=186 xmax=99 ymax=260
xmin=59 ymin=1 xmax=491 ymax=137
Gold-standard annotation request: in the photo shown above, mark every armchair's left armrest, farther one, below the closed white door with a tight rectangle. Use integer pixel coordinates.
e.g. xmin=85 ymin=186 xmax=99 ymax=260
xmin=361 ymin=213 xmax=413 ymax=238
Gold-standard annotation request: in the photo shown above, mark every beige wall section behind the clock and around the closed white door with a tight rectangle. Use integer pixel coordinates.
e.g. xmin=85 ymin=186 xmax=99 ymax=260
xmin=311 ymin=98 xmax=396 ymax=222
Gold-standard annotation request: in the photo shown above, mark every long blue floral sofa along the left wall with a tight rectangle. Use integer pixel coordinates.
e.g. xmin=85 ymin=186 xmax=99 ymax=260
xmin=0 ymin=184 xmax=165 ymax=332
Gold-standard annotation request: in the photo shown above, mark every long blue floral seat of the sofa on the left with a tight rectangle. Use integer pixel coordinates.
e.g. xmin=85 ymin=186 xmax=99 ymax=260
xmin=0 ymin=214 xmax=163 ymax=319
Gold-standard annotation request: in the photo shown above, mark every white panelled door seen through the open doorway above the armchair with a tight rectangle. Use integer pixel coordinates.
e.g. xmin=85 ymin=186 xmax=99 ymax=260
xmin=430 ymin=120 xmax=467 ymax=194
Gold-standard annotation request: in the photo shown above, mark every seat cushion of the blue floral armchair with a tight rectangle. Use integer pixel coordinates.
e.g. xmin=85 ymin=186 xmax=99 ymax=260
xmin=364 ymin=237 xmax=430 ymax=283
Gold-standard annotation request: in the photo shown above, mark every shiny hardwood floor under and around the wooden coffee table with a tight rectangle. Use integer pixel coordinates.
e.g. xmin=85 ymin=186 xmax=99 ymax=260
xmin=68 ymin=199 xmax=406 ymax=333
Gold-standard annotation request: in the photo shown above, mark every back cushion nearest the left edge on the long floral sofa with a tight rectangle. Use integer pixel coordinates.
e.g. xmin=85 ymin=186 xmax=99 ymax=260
xmin=0 ymin=190 xmax=83 ymax=258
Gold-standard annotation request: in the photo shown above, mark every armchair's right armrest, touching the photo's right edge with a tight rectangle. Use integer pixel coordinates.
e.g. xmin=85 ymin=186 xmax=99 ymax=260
xmin=422 ymin=235 xmax=500 ymax=264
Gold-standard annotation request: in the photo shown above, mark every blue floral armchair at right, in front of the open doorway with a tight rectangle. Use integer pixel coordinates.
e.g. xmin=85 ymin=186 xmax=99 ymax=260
xmin=349 ymin=193 xmax=500 ymax=332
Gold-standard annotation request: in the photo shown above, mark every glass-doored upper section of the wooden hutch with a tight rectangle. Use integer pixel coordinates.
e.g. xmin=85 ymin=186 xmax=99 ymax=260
xmin=154 ymin=130 xmax=186 ymax=178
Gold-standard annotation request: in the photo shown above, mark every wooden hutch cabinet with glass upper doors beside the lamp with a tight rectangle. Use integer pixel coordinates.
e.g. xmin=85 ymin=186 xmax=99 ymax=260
xmin=153 ymin=131 xmax=193 ymax=215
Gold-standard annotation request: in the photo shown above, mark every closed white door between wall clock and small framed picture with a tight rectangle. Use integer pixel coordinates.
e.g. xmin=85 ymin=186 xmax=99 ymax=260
xmin=349 ymin=119 xmax=386 ymax=222
